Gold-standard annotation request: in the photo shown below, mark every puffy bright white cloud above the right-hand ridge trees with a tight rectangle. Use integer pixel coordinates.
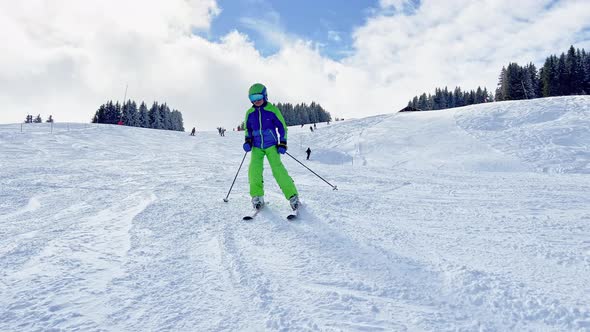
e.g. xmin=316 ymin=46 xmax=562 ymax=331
xmin=346 ymin=0 xmax=590 ymax=105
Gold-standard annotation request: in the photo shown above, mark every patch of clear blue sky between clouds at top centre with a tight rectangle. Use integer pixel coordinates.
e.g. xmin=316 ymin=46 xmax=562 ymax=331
xmin=207 ymin=0 xmax=379 ymax=60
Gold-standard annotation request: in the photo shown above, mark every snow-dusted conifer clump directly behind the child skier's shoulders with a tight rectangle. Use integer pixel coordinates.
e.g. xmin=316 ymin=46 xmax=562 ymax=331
xmin=238 ymin=101 xmax=332 ymax=130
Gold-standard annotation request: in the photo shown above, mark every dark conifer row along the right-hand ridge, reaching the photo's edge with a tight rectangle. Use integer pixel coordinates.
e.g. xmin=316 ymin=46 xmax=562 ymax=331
xmin=408 ymin=45 xmax=590 ymax=111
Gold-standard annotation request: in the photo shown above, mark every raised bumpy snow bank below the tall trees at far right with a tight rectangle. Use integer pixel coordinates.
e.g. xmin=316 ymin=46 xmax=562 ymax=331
xmin=455 ymin=96 xmax=590 ymax=174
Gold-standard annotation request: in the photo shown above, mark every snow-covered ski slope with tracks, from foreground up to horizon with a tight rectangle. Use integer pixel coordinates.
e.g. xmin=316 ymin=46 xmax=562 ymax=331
xmin=0 ymin=96 xmax=590 ymax=331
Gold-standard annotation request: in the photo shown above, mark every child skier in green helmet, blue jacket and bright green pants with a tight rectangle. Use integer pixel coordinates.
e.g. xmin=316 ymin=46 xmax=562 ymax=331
xmin=243 ymin=83 xmax=299 ymax=210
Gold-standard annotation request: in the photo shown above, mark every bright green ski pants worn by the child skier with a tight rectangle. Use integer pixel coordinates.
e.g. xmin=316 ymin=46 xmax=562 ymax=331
xmin=248 ymin=146 xmax=297 ymax=199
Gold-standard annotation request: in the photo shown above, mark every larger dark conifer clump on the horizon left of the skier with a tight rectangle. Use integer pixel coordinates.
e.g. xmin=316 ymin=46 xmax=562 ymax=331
xmin=92 ymin=100 xmax=184 ymax=131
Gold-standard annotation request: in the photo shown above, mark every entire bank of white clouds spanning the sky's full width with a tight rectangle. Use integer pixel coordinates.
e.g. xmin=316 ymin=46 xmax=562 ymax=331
xmin=0 ymin=0 xmax=590 ymax=129
